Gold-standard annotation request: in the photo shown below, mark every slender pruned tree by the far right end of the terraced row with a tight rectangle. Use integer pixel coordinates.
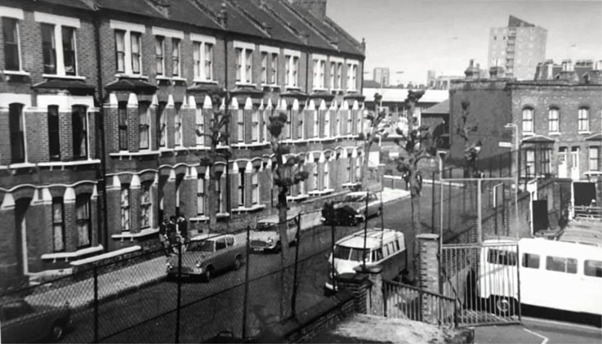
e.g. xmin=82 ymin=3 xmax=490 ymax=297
xmin=358 ymin=93 xmax=388 ymax=190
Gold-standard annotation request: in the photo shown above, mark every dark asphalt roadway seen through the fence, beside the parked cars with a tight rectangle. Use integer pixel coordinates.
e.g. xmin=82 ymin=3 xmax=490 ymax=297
xmin=59 ymin=194 xmax=414 ymax=342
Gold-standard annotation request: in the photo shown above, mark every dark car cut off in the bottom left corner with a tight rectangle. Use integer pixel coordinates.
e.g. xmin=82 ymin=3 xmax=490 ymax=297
xmin=0 ymin=300 xmax=72 ymax=343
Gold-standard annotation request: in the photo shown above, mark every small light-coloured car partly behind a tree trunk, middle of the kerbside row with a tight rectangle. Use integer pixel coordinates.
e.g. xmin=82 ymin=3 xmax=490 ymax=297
xmin=250 ymin=214 xmax=298 ymax=253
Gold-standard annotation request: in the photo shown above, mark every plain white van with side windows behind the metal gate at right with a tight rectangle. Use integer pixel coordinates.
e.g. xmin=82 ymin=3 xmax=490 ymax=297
xmin=478 ymin=238 xmax=602 ymax=315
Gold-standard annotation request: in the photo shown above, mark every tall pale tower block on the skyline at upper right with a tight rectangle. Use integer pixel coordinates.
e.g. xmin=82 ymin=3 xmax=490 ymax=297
xmin=489 ymin=16 xmax=548 ymax=80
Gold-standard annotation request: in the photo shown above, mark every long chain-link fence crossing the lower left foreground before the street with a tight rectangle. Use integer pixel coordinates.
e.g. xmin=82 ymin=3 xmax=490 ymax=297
xmin=0 ymin=213 xmax=370 ymax=343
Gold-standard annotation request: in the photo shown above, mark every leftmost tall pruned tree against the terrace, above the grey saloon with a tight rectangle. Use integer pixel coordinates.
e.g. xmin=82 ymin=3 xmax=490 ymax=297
xmin=196 ymin=96 xmax=231 ymax=232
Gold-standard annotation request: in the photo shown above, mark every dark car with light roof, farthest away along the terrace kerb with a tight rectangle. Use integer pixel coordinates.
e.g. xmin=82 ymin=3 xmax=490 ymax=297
xmin=322 ymin=191 xmax=382 ymax=225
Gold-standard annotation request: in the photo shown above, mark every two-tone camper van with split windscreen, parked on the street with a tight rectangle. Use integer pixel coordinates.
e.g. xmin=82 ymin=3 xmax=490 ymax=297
xmin=324 ymin=228 xmax=407 ymax=291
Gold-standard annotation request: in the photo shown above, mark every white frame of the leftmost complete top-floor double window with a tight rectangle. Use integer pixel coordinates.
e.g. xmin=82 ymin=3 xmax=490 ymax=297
xmin=34 ymin=12 xmax=84 ymax=79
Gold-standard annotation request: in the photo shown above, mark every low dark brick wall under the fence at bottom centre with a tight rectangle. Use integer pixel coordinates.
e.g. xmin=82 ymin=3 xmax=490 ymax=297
xmin=255 ymin=290 xmax=356 ymax=343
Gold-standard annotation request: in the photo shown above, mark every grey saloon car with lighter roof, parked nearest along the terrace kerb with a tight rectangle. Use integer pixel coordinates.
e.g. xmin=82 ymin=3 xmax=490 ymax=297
xmin=167 ymin=234 xmax=246 ymax=282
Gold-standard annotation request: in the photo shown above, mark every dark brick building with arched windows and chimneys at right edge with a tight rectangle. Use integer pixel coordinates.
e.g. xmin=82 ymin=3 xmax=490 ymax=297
xmin=450 ymin=60 xmax=602 ymax=181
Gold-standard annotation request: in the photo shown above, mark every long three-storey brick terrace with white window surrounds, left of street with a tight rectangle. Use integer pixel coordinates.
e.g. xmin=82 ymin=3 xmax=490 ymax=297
xmin=0 ymin=0 xmax=365 ymax=281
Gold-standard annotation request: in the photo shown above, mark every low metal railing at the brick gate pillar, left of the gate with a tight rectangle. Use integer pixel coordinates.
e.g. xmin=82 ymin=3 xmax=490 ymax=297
xmin=383 ymin=280 xmax=458 ymax=327
